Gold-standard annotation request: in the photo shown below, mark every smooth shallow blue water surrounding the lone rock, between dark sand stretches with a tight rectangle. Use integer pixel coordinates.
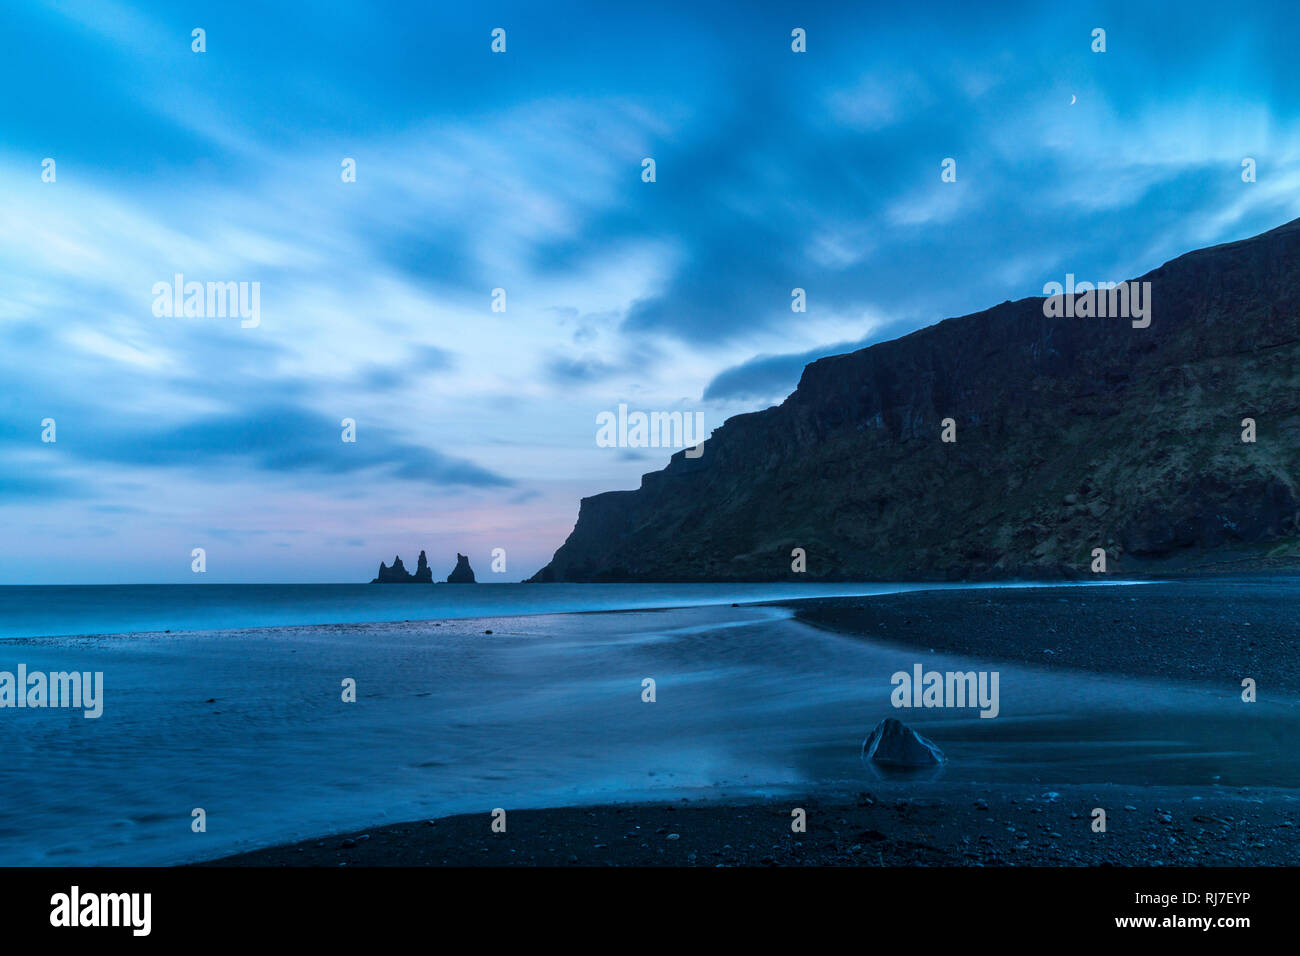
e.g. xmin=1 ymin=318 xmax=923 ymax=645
xmin=0 ymin=589 xmax=1300 ymax=865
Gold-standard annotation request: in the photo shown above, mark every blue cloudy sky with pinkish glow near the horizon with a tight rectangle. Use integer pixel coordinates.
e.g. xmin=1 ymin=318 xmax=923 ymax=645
xmin=0 ymin=0 xmax=1300 ymax=584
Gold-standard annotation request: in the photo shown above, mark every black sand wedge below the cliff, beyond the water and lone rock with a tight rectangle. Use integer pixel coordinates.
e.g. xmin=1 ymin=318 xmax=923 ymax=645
xmin=789 ymin=578 xmax=1300 ymax=700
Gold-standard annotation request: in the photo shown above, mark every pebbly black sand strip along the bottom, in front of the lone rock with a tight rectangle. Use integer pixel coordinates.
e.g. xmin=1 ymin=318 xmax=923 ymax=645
xmin=200 ymin=784 xmax=1300 ymax=868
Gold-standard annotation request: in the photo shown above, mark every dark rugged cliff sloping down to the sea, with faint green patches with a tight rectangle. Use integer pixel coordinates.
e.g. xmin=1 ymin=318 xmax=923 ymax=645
xmin=533 ymin=220 xmax=1300 ymax=581
